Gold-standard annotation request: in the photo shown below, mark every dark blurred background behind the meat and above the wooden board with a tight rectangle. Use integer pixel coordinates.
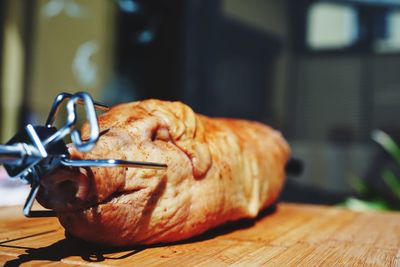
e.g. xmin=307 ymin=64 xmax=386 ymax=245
xmin=0 ymin=0 xmax=400 ymax=209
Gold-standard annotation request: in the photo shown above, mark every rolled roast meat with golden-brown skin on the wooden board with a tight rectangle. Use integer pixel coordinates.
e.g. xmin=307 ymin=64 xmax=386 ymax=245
xmin=39 ymin=100 xmax=289 ymax=245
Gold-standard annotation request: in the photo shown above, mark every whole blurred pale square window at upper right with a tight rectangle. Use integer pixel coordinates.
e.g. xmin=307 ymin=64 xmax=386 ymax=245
xmin=306 ymin=3 xmax=359 ymax=50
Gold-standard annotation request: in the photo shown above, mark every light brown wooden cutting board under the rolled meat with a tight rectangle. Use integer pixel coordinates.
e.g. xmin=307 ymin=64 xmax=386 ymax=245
xmin=0 ymin=203 xmax=400 ymax=266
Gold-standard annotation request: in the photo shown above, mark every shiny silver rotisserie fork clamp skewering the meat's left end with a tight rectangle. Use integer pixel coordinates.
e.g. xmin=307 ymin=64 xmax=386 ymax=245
xmin=0 ymin=92 xmax=167 ymax=217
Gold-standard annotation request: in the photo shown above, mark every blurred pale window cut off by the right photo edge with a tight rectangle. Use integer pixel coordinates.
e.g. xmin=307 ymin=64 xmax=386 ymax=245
xmin=373 ymin=9 xmax=400 ymax=53
